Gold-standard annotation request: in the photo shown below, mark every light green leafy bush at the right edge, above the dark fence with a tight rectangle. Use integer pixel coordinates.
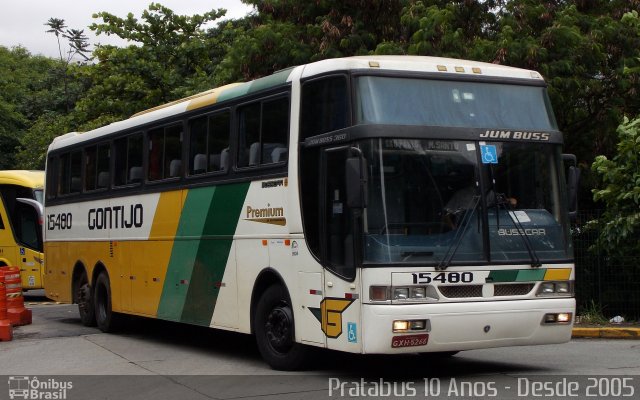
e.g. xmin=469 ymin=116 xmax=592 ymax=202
xmin=592 ymin=118 xmax=640 ymax=255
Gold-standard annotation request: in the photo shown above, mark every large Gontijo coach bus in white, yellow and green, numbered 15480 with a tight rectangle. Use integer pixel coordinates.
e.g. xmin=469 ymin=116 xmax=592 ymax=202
xmin=45 ymin=56 xmax=575 ymax=369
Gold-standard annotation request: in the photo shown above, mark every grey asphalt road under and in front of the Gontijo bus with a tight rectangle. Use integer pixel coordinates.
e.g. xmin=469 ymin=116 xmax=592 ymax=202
xmin=0 ymin=293 xmax=640 ymax=400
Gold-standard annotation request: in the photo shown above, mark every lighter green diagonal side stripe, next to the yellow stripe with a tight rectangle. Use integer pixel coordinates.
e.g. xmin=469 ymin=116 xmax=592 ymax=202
xmin=158 ymin=187 xmax=216 ymax=321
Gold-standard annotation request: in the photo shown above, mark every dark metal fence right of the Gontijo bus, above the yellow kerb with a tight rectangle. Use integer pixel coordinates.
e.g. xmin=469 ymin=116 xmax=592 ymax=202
xmin=572 ymin=210 xmax=640 ymax=321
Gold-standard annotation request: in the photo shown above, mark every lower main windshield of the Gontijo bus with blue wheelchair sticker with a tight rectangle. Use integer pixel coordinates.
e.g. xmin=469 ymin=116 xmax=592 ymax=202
xmin=358 ymin=139 xmax=571 ymax=265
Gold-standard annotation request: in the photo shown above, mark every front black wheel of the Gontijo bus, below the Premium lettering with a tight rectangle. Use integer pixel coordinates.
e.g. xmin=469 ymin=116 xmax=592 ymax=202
xmin=253 ymin=285 xmax=308 ymax=371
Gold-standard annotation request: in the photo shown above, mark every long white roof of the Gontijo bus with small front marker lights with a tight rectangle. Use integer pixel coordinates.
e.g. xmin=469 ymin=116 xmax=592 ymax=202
xmin=49 ymin=56 xmax=543 ymax=151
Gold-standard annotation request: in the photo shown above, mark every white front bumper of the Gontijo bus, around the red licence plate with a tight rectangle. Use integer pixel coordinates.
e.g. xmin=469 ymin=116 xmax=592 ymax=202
xmin=362 ymin=298 xmax=576 ymax=354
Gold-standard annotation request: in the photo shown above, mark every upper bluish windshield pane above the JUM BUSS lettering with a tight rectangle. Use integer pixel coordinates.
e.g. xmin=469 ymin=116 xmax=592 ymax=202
xmin=356 ymin=76 xmax=558 ymax=130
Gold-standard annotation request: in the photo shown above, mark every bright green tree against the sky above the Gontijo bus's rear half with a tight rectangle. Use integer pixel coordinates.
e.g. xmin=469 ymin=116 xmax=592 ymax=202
xmin=77 ymin=3 xmax=226 ymax=122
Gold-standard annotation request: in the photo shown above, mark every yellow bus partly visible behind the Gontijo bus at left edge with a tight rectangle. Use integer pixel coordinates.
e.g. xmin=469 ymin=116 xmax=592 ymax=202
xmin=0 ymin=170 xmax=44 ymax=290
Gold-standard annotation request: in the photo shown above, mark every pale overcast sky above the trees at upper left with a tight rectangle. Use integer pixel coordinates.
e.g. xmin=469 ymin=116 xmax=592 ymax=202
xmin=0 ymin=0 xmax=252 ymax=57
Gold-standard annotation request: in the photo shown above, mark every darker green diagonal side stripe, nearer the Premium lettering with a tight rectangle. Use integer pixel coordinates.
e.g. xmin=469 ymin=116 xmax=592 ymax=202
xmin=181 ymin=183 xmax=249 ymax=326
